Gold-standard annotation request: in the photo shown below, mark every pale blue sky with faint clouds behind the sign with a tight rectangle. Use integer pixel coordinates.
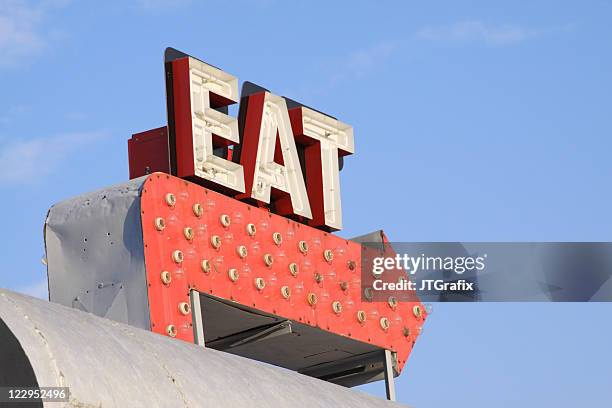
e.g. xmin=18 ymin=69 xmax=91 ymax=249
xmin=0 ymin=0 xmax=612 ymax=408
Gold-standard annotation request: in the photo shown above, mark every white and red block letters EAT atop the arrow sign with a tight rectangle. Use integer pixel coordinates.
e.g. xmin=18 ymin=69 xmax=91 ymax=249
xmin=166 ymin=54 xmax=355 ymax=230
